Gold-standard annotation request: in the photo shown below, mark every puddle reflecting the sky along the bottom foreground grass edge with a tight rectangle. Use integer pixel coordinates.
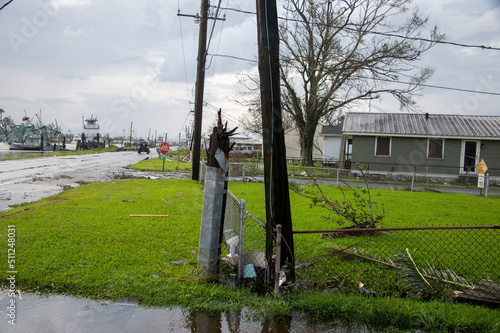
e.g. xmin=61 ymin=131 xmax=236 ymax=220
xmin=0 ymin=292 xmax=386 ymax=333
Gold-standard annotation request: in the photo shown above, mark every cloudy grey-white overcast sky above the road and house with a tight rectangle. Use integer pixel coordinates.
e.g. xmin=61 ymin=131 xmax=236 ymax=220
xmin=0 ymin=0 xmax=500 ymax=138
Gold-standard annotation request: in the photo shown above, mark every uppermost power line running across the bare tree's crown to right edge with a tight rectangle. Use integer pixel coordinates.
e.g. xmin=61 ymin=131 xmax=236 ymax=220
xmin=222 ymin=7 xmax=500 ymax=51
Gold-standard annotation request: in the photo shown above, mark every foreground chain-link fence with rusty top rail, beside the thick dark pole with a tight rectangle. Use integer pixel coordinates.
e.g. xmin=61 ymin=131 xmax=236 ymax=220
xmin=222 ymin=187 xmax=500 ymax=304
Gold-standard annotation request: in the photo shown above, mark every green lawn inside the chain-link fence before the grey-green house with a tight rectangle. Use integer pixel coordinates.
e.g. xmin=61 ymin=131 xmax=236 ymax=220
xmin=229 ymin=183 xmax=500 ymax=296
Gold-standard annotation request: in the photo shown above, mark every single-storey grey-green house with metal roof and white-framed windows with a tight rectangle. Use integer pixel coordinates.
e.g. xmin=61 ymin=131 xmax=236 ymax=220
xmin=343 ymin=112 xmax=500 ymax=176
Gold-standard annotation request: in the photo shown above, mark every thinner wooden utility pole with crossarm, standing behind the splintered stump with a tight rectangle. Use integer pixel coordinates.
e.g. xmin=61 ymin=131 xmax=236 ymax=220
xmin=191 ymin=0 xmax=209 ymax=180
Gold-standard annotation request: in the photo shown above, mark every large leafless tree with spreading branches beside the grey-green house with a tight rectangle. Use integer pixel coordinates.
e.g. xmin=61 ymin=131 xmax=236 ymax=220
xmin=280 ymin=0 xmax=444 ymax=165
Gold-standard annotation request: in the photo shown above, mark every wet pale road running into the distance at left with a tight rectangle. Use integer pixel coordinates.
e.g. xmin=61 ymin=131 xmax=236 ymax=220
xmin=0 ymin=151 xmax=149 ymax=211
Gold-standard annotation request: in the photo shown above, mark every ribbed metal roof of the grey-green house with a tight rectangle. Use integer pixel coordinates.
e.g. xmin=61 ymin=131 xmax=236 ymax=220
xmin=343 ymin=112 xmax=500 ymax=140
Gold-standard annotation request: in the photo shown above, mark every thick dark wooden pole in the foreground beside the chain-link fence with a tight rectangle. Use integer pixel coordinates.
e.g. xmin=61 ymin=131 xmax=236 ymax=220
xmin=257 ymin=0 xmax=295 ymax=283
